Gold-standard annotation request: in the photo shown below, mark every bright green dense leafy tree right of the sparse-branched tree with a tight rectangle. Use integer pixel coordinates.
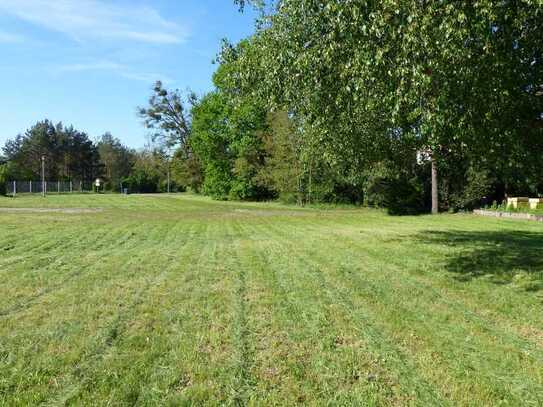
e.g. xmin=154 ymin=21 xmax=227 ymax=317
xmin=189 ymin=74 xmax=271 ymax=200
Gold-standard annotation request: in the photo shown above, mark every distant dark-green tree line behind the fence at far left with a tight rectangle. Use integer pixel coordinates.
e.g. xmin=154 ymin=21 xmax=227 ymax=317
xmin=0 ymin=120 xmax=180 ymax=193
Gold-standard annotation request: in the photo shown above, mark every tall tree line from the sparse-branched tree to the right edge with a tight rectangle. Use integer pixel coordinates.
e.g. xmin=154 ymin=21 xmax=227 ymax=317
xmin=2 ymin=0 xmax=543 ymax=213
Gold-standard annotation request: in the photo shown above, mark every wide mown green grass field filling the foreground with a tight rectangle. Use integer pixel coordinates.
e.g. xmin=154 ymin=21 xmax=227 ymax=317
xmin=0 ymin=195 xmax=543 ymax=406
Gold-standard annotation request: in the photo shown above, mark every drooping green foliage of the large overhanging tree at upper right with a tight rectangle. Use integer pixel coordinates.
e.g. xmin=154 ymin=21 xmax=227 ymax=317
xmin=227 ymin=0 xmax=543 ymax=214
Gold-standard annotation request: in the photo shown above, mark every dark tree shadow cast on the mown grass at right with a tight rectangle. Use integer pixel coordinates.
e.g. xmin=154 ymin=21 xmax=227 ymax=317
xmin=418 ymin=231 xmax=543 ymax=291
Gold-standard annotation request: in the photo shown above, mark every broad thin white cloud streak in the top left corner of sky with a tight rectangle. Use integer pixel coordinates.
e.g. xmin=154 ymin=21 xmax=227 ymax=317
xmin=0 ymin=0 xmax=188 ymax=44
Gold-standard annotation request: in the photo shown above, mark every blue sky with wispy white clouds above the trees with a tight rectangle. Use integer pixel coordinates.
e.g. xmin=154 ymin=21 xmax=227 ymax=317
xmin=0 ymin=0 xmax=253 ymax=148
